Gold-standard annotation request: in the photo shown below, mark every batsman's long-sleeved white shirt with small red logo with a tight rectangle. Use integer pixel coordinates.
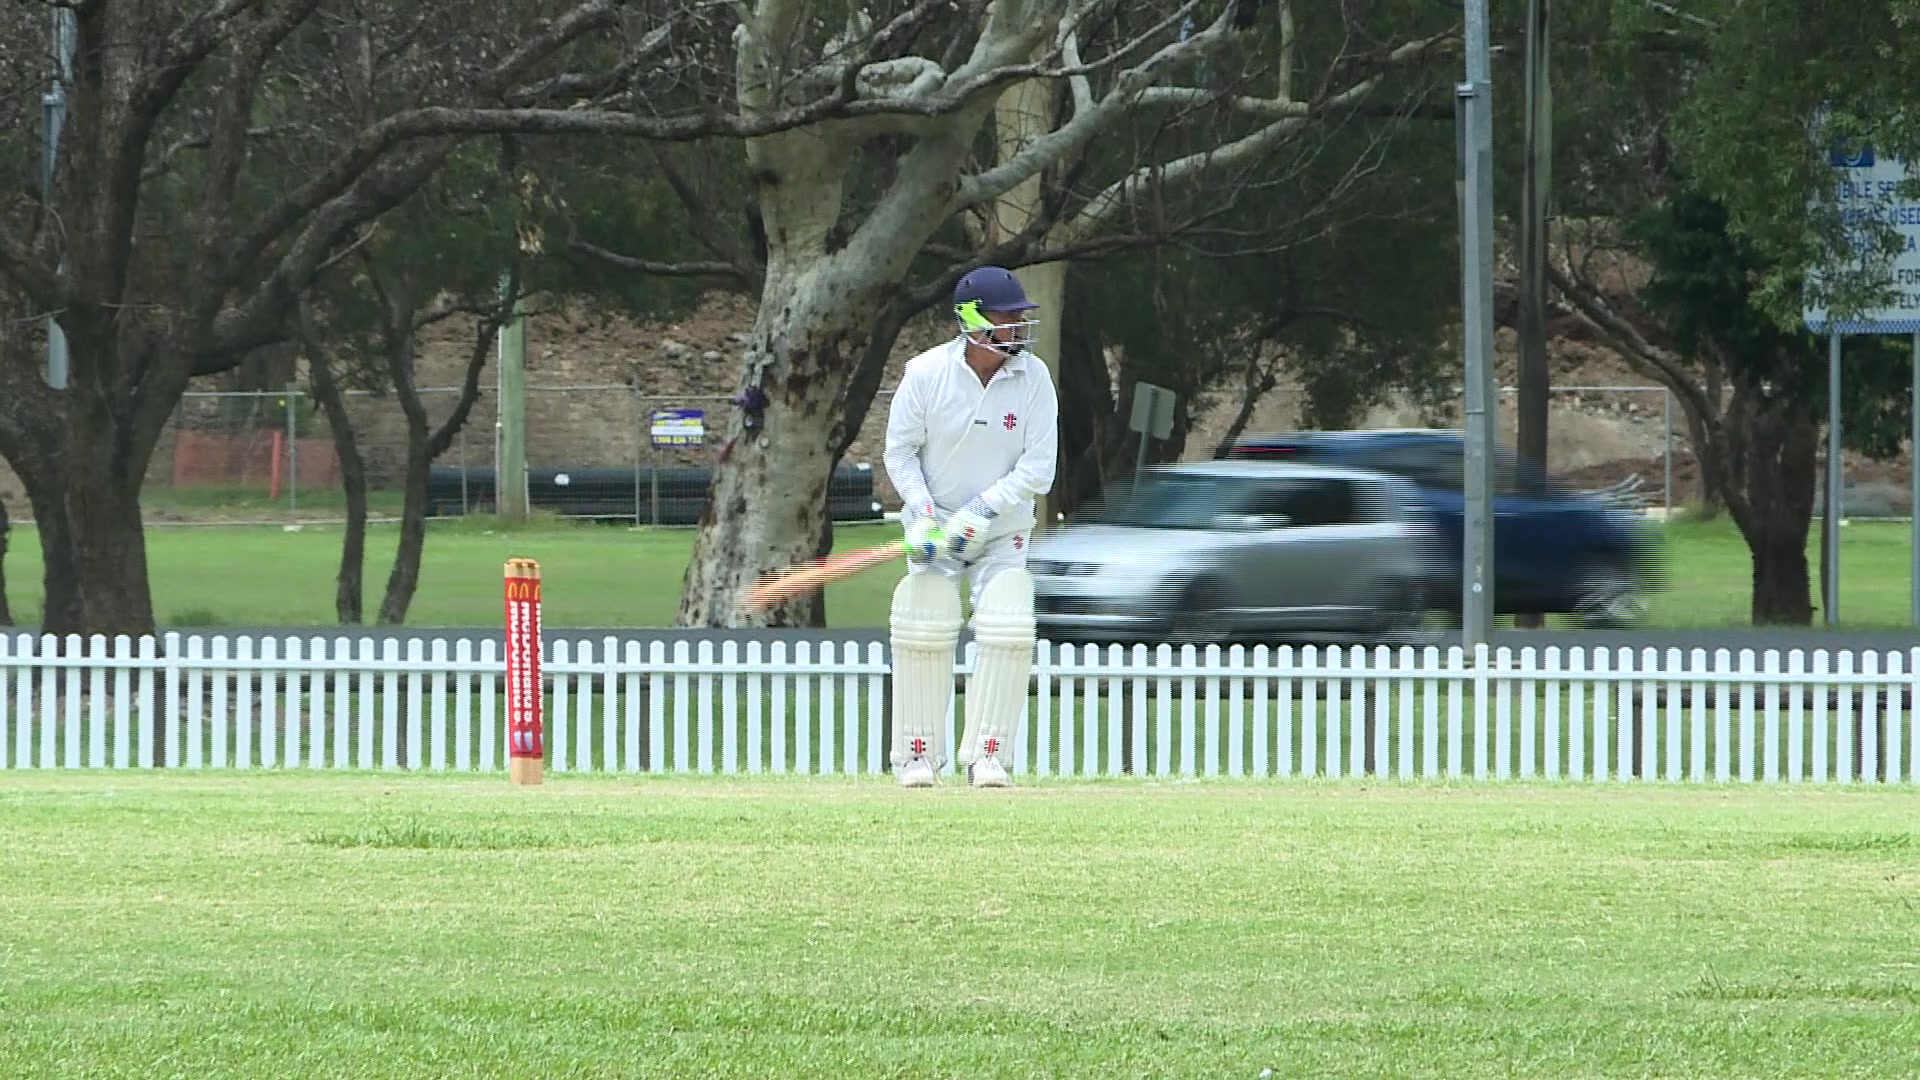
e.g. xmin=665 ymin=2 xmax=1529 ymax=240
xmin=881 ymin=336 xmax=1060 ymax=536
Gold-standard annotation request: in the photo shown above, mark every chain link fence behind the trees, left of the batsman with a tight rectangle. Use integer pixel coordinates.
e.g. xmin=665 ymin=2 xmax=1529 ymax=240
xmin=120 ymin=384 xmax=893 ymax=525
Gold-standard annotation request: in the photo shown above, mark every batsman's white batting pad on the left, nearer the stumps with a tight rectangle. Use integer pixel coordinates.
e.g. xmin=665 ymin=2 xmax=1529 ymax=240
xmin=891 ymin=573 xmax=960 ymax=773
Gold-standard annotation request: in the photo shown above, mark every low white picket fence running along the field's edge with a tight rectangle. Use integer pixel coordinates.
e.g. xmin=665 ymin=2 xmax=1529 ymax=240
xmin=0 ymin=632 xmax=1920 ymax=784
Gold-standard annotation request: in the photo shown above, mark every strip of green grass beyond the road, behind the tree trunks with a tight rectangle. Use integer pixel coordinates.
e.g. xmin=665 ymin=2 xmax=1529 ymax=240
xmin=6 ymin=519 xmax=1908 ymax=626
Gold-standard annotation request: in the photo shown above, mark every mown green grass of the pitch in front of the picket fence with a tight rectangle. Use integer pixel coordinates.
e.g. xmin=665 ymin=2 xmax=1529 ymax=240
xmin=0 ymin=774 xmax=1920 ymax=1080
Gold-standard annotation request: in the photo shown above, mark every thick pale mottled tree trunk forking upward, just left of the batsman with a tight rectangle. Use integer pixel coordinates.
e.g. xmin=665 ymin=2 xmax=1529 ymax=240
xmin=676 ymin=27 xmax=1006 ymax=626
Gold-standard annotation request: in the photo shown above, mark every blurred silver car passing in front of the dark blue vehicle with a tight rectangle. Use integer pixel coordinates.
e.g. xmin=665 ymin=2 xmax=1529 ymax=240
xmin=1027 ymin=461 xmax=1440 ymax=642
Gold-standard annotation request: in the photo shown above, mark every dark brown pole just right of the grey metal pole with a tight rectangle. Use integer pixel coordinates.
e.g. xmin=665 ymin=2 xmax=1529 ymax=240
xmin=1515 ymin=0 xmax=1553 ymax=626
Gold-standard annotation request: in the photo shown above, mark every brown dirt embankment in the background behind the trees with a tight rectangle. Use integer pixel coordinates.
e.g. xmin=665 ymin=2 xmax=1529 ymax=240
xmin=0 ymin=294 xmax=1907 ymax=517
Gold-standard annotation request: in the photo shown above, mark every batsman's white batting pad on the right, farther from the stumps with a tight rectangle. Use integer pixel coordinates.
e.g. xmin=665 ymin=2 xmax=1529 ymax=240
xmin=960 ymin=567 xmax=1033 ymax=767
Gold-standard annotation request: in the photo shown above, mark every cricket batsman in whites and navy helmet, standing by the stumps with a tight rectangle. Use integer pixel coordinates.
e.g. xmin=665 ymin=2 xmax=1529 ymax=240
xmin=883 ymin=267 xmax=1060 ymax=788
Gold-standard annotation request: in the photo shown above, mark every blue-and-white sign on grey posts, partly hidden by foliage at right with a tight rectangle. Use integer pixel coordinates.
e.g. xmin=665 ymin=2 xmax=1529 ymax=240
xmin=1801 ymin=146 xmax=1920 ymax=626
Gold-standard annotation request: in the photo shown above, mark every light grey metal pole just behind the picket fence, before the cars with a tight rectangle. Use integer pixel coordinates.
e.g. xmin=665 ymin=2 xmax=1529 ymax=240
xmin=1453 ymin=0 xmax=1496 ymax=651
